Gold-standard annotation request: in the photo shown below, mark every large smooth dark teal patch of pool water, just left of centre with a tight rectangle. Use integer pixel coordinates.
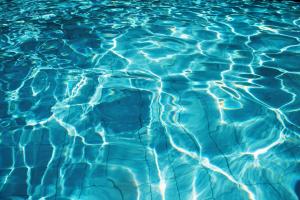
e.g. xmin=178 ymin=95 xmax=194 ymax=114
xmin=90 ymin=89 xmax=151 ymax=133
